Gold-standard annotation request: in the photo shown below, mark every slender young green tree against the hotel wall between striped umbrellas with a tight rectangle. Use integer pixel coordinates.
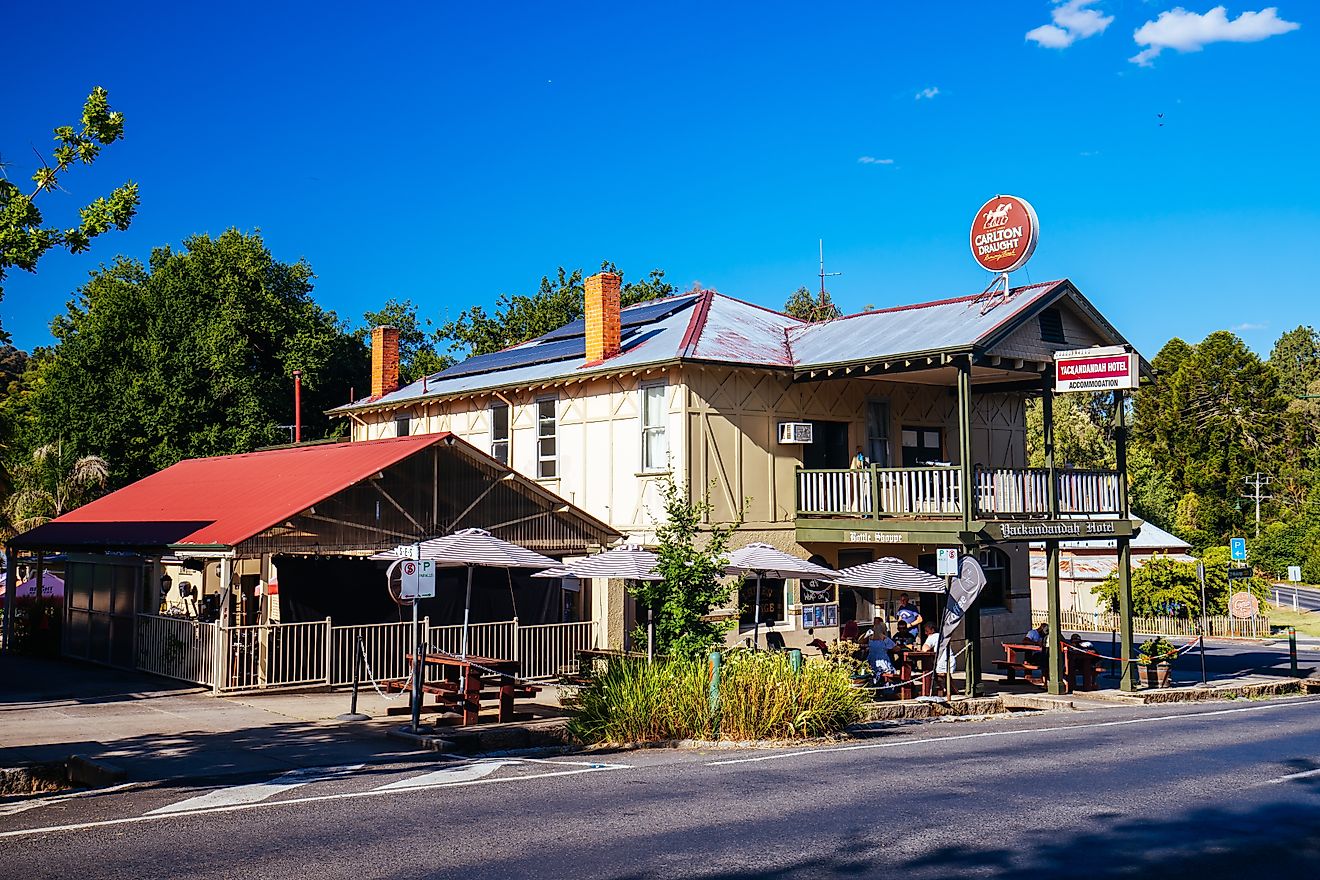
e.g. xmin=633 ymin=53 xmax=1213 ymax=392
xmin=632 ymin=480 xmax=742 ymax=657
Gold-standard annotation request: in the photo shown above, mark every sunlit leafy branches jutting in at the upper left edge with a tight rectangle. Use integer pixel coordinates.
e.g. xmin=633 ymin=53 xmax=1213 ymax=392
xmin=0 ymin=86 xmax=137 ymax=342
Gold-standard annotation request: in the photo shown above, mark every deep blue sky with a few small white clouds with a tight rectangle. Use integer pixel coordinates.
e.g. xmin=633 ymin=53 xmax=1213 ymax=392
xmin=0 ymin=0 xmax=1320 ymax=356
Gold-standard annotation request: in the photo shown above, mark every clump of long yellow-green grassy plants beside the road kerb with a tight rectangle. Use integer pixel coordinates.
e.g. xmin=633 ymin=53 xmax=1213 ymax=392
xmin=565 ymin=652 xmax=866 ymax=743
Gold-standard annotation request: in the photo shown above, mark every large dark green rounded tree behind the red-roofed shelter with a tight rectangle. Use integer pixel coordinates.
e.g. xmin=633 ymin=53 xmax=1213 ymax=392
xmin=29 ymin=230 xmax=368 ymax=486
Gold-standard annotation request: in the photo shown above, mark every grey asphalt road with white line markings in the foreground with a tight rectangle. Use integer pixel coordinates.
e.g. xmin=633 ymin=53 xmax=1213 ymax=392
xmin=0 ymin=698 xmax=1320 ymax=880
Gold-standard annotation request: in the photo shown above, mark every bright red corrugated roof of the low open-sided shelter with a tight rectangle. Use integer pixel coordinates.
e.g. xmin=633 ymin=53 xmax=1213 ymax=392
xmin=15 ymin=433 xmax=449 ymax=546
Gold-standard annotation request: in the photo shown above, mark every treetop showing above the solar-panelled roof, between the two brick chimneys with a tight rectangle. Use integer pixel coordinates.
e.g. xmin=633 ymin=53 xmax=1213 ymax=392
xmin=436 ymin=261 xmax=673 ymax=356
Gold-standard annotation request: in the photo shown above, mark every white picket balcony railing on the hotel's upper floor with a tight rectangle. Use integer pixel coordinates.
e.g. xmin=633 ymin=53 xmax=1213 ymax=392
xmin=797 ymin=466 xmax=1119 ymax=520
